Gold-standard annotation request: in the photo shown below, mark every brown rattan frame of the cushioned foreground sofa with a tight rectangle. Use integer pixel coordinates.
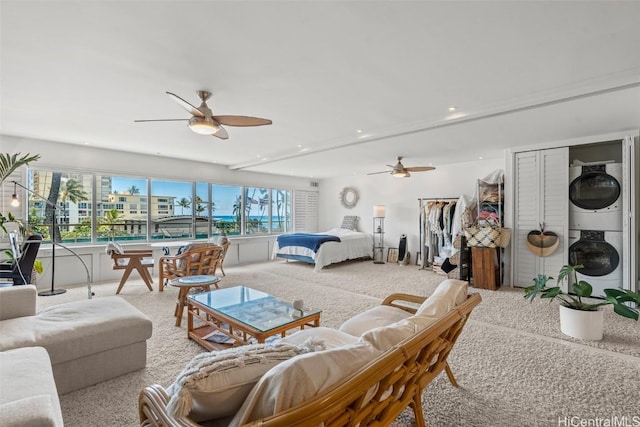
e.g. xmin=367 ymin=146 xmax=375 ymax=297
xmin=138 ymin=294 xmax=481 ymax=427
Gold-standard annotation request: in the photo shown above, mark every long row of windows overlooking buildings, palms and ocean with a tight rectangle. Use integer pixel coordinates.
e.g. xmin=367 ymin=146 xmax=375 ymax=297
xmin=27 ymin=169 xmax=292 ymax=243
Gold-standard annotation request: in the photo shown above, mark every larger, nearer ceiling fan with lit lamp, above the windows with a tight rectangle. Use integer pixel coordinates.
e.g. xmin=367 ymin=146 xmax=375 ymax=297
xmin=134 ymin=90 xmax=272 ymax=139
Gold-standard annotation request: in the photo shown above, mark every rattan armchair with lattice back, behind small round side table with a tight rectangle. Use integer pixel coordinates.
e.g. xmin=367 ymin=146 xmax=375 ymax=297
xmin=159 ymin=243 xmax=223 ymax=292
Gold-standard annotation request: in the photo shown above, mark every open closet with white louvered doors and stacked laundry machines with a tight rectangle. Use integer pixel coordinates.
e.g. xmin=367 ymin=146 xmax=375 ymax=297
xmin=511 ymin=132 xmax=640 ymax=296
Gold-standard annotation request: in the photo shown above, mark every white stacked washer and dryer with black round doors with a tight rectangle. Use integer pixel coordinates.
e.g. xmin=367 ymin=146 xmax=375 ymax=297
xmin=569 ymin=162 xmax=622 ymax=297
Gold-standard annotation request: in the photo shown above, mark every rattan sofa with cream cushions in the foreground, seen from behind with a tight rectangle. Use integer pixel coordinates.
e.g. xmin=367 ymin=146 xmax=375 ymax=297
xmin=139 ymin=279 xmax=481 ymax=427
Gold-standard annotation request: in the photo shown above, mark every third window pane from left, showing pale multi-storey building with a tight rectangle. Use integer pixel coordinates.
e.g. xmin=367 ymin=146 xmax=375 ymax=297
xmin=150 ymin=180 xmax=194 ymax=239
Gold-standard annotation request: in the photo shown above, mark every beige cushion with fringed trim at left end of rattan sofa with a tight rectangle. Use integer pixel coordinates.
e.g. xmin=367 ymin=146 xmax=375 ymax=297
xmin=167 ymin=342 xmax=324 ymax=422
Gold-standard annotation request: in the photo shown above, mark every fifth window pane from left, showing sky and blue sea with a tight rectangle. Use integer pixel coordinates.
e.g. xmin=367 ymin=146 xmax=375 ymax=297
xmin=211 ymin=184 xmax=242 ymax=235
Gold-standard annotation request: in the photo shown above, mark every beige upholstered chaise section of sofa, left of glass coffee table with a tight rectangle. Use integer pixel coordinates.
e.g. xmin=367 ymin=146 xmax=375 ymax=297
xmin=0 ymin=285 xmax=152 ymax=394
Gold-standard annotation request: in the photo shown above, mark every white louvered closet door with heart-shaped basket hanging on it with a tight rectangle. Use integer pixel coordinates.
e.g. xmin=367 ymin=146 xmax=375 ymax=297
xmin=513 ymin=148 xmax=569 ymax=287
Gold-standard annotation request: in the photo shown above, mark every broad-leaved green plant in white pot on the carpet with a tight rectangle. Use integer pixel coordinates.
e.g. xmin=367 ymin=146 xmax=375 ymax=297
xmin=524 ymin=264 xmax=640 ymax=341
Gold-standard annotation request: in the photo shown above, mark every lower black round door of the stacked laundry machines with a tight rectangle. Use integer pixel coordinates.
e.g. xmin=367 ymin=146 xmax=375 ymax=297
xmin=569 ymin=230 xmax=620 ymax=277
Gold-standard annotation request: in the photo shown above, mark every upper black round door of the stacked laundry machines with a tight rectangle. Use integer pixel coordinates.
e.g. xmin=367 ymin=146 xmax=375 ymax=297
xmin=569 ymin=165 xmax=620 ymax=210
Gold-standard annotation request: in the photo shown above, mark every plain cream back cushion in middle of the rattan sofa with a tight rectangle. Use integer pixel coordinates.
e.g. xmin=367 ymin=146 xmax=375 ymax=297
xmin=228 ymin=341 xmax=380 ymax=427
